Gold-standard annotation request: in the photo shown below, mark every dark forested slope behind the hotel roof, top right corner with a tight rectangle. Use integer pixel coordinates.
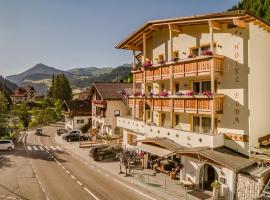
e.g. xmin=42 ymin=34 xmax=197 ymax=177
xmin=229 ymin=0 xmax=270 ymax=23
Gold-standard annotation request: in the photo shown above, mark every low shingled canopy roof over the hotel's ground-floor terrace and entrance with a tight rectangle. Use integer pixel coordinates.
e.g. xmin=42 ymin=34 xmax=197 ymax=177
xmin=138 ymin=137 xmax=256 ymax=172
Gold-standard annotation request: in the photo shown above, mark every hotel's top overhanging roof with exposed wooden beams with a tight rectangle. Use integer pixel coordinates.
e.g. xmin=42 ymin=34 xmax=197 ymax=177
xmin=116 ymin=10 xmax=270 ymax=50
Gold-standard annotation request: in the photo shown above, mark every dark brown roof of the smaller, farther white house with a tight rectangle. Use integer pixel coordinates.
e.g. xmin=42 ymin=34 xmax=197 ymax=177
xmin=63 ymin=100 xmax=92 ymax=115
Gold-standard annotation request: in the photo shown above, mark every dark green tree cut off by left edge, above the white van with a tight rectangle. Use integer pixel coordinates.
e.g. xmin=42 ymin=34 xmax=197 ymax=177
xmin=0 ymin=91 xmax=9 ymax=136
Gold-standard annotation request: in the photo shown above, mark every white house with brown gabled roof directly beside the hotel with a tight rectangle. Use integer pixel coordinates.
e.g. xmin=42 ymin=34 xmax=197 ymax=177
xmin=89 ymin=82 xmax=139 ymax=137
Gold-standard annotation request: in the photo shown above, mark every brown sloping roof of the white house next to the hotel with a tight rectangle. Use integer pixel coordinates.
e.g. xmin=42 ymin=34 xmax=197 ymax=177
xmin=92 ymin=82 xmax=133 ymax=100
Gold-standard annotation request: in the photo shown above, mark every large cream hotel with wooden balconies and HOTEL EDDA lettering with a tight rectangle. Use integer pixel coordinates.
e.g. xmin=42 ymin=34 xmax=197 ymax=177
xmin=116 ymin=11 xmax=270 ymax=199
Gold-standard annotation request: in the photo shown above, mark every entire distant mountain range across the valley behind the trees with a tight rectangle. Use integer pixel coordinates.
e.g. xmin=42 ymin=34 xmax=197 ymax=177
xmin=7 ymin=63 xmax=131 ymax=95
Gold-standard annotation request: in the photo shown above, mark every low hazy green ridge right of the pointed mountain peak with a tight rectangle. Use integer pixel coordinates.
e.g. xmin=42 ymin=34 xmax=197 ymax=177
xmin=67 ymin=67 xmax=112 ymax=76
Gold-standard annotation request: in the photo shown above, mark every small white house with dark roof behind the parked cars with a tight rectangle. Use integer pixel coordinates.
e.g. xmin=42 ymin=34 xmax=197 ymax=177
xmin=62 ymin=100 xmax=91 ymax=130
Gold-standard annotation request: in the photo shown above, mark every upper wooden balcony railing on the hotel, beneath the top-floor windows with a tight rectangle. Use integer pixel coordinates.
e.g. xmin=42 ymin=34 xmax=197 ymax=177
xmin=133 ymin=55 xmax=224 ymax=83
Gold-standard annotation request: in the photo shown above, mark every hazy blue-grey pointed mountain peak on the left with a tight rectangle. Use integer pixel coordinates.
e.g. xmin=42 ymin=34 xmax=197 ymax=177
xmin=6 ymin=63 xmax=73 ymax=86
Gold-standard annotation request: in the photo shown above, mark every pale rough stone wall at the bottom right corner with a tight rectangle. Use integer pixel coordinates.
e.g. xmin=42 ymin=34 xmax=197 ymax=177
xmin=236 ymin=173 xmax=264 ymax=200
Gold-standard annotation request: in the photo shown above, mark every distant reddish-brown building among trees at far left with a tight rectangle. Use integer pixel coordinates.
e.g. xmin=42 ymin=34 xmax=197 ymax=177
xmin=11 ymin=85 xmax=36 ymax=104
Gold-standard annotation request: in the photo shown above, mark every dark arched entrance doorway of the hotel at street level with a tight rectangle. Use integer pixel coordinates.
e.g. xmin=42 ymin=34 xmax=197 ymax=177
xmin=200 ymin=164 xmax=218 ymax=191
